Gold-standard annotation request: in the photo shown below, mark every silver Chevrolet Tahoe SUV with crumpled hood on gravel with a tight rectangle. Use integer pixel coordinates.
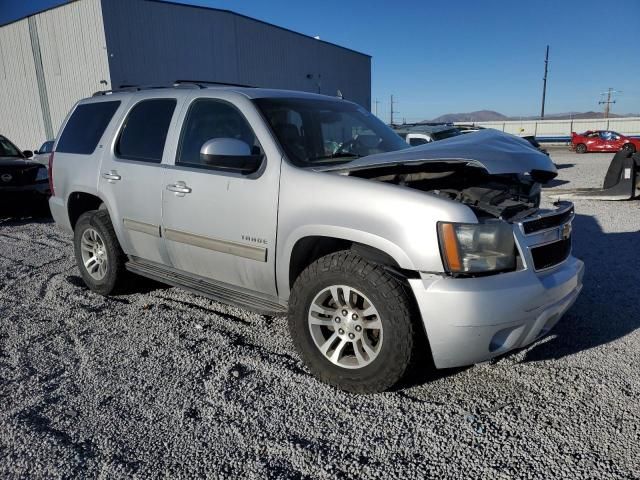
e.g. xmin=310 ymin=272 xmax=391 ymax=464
xmin=50 ymin=84 xmax=583 ymax=392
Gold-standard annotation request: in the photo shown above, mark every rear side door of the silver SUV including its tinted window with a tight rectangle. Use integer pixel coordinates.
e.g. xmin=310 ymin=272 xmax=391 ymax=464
xmin=99 ymin=96 xmax=178 ymax=264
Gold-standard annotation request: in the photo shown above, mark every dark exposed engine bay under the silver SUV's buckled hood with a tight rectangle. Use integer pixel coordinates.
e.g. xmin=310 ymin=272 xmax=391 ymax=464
xmin=349 ymin=162 xmax=555 ymax=222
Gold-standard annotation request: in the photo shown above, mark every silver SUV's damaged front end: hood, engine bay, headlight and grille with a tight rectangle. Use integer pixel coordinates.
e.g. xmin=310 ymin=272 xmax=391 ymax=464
xmin=320 ymin=132 xmax=573 ymax=276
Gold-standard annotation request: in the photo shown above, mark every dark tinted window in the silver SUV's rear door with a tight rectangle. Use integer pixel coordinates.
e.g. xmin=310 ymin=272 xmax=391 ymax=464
xmin=115 ymin=98 xmax=176 ymax=163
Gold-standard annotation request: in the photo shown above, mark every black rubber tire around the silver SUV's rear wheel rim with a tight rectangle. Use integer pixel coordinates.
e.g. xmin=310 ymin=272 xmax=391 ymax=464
xmin=73 ymin=210 xmax=127 ymax=295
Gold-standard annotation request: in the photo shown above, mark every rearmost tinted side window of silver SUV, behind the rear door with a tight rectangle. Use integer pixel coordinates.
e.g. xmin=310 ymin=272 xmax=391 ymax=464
xmin=56 ymin=101 xmax=120 ymax=155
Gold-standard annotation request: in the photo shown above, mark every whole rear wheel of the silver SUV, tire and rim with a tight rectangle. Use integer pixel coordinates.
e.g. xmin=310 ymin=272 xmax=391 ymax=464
xmin=73 ymin=210 xmax=126 ymax=295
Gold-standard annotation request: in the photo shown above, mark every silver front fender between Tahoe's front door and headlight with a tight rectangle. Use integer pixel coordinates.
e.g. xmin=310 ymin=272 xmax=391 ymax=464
xmin=276 ymin=163 xmax=478 ymax=299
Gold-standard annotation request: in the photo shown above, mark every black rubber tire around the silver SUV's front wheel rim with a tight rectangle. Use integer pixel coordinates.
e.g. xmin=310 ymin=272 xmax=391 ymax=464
xmin=289 ymin=250 xmax=423 ymax=393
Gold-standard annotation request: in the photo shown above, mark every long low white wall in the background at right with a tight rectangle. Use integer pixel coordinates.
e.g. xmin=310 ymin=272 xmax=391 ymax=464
xmin=459 ymin=117 xmax=640 ymax=140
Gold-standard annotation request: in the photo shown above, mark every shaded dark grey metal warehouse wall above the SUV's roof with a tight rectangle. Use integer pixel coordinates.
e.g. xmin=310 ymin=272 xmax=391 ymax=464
xmin=102 ymin=0 xmax=371 ymax=109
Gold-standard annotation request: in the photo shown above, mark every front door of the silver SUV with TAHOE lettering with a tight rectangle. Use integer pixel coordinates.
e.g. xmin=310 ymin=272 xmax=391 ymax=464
xmin=162 ymin=98 xmax=281 ymax=295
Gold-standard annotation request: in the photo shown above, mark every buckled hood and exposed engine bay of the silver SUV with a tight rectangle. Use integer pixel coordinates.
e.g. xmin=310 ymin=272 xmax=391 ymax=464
xmin=326 ymin=130 xmax=557 ymax=222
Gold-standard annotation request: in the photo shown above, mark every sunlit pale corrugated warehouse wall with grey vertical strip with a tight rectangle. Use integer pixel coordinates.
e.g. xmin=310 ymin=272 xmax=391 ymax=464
xmin=0 ymin=0 xmax=110 ymax=149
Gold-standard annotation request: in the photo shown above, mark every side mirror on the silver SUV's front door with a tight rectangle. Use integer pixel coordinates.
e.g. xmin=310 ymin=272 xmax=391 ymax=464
xmin=200 ymin=138 xmax=262 ymax=174
